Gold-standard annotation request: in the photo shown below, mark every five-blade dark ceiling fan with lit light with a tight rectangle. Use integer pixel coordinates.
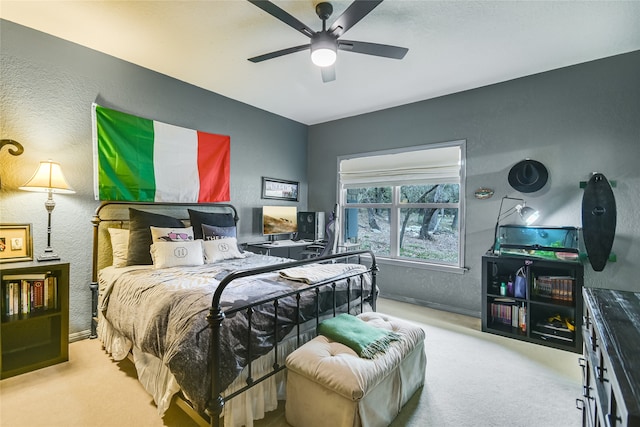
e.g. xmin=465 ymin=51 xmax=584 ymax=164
xmin=248 ymin=0 xmax=409 ymax=83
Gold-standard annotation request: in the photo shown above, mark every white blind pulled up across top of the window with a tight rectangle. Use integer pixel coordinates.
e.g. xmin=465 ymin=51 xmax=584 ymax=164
xmin=340 ymin=145 xmax=461 ymax=187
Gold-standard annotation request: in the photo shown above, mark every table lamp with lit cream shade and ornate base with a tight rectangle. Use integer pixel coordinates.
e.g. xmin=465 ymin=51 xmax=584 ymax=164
xmin=20 ymin=160 xmax=75 ymax=261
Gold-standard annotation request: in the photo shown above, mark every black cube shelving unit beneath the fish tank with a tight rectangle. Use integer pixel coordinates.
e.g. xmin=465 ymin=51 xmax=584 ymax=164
xmin=482 ymin=254 xmax=584 ymax=353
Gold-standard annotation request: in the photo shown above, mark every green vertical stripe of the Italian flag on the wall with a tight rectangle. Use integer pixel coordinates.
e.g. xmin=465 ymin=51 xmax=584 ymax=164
xmin=96 ymin=105 xmax=156 ymax=202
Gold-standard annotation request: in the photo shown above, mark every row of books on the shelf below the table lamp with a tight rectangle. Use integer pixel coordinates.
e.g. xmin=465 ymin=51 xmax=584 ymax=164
xmin=2 ymin=273 xmax=58 ymax=316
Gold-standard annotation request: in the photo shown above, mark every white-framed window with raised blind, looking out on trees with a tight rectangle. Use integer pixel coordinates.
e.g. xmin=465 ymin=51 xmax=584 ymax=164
xmin=338 ymin=141 xmax=465 ymax=267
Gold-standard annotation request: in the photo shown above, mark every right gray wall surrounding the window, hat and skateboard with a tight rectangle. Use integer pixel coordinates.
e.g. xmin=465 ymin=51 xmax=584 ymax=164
xmin=308 ymin=52 xmax=640 ymax=314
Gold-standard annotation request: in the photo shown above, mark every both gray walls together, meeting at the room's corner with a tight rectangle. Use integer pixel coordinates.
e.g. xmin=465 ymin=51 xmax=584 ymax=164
xmin=0 ymin=20 xmax=640 ymax=333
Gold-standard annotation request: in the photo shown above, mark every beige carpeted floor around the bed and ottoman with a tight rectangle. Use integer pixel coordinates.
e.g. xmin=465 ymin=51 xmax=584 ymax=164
xmin=0 ymin=299 xmax=581 ymax=427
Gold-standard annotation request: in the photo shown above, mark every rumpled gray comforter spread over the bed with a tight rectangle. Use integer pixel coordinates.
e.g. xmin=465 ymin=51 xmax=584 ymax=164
xmin=100 ymin=255 xmax=371 ymax=412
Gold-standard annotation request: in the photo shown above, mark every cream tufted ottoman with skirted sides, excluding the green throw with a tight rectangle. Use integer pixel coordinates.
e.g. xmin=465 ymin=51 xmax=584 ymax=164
xmin=285 ymin=312 xmax=426 ymax=427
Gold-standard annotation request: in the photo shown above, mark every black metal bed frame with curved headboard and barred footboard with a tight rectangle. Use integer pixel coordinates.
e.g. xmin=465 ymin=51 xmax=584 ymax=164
xmin=89 ymin=202 xmax=378 ymax=427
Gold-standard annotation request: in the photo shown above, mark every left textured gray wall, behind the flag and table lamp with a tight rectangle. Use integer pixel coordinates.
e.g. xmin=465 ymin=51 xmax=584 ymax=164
xmin=0 ymin=20 xmax=307 ymax=340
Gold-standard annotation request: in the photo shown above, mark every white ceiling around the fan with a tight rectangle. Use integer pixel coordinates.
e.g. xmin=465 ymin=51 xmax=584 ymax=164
xmin=0 ymin=0 xmax=640 ymax=124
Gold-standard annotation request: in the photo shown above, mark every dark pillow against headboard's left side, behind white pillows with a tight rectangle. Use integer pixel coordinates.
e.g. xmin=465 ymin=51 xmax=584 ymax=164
xmin=127 ymin=208 xmax=184 ymax=265
